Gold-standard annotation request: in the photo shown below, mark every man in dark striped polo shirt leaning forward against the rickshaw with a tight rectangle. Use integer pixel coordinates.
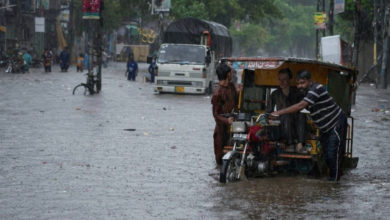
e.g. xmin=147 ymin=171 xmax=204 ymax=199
xmin=272 ymin=70 xmax=347 ymax=181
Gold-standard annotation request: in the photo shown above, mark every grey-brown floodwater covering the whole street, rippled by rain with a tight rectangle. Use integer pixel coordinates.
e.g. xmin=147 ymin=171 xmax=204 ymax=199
xmin=0 ymin=63 xmax=390 ymax=219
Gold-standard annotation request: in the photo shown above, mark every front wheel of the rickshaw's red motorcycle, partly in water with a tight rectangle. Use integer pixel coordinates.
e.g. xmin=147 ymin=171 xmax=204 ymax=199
xmin=219 ymin=153 xmax=241 ymax=183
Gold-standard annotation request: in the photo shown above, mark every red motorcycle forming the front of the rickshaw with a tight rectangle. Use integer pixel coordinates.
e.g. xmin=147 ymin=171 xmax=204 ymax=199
xmin=219 ymin=113 xmax=286 ymax=183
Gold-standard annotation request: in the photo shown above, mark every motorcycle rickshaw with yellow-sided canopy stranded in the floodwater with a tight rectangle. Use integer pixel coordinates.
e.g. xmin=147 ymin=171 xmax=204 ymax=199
xmin=220 ymin=58 xmax=358 ymax=182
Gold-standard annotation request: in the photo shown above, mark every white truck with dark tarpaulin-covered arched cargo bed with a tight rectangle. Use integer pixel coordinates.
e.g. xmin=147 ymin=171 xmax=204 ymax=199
xmin=154 ymin=18 xmax=232 ymax=94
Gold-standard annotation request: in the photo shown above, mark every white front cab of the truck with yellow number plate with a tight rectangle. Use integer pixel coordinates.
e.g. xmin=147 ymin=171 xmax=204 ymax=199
xmin=154 ymin=43 xmax=215 ymax=94
